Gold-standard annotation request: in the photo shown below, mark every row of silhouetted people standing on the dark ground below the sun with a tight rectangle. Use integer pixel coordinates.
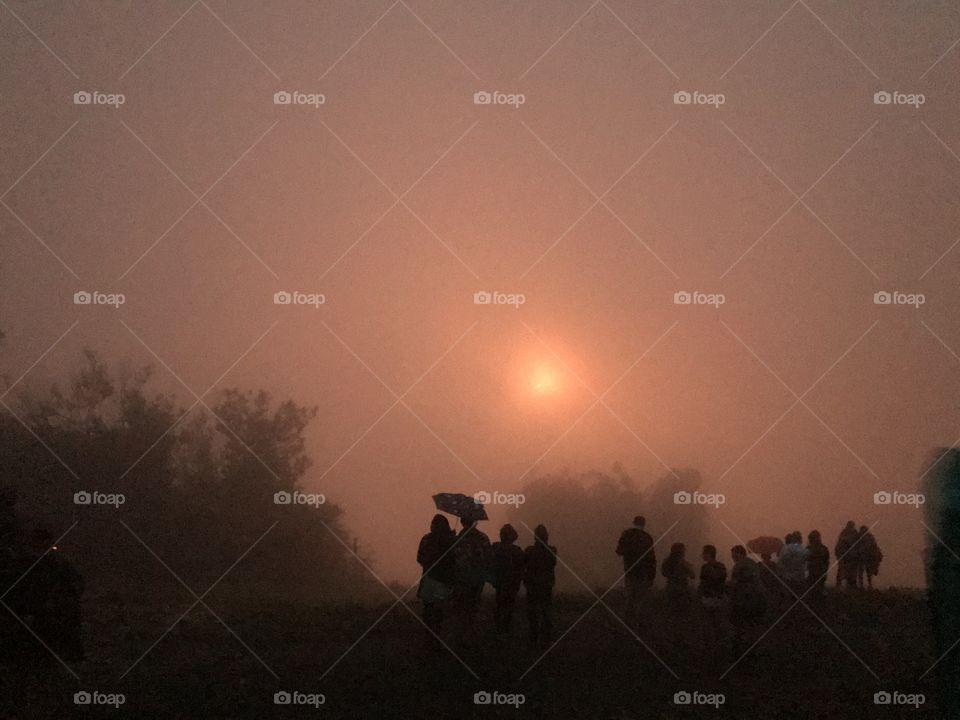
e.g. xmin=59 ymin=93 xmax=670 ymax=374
xmin=417 ymin=514 xmax=883 ymax=652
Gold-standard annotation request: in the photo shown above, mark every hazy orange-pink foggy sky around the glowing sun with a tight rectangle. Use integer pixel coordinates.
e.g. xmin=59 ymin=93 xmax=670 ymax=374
xmin=0 ymin=0 xmax=960 ymax=584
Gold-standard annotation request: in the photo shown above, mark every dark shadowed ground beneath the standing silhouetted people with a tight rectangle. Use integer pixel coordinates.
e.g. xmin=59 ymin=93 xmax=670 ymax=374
xmin=0 ymin=590 xmax=937 ymax=720
